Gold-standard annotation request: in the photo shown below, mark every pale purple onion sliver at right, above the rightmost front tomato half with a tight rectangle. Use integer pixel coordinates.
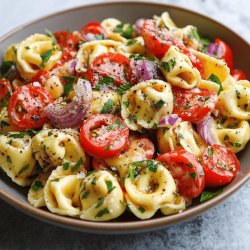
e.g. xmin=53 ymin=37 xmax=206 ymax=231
xmin=197 ymin=115 xmax=216 ymax=145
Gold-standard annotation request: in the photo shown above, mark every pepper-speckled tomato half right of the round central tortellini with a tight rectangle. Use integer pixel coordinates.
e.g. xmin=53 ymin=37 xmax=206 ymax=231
xmin=173 ymin=87 xmax=218 ymax=123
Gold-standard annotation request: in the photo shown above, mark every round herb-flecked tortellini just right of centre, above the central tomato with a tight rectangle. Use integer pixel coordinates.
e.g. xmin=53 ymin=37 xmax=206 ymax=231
xmin=121 ymin=80 xmax=173 ymax=130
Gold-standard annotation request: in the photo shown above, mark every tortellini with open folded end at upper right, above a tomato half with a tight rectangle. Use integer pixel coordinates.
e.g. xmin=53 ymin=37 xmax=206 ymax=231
xmin=162 ymin=46 xmax=201 ymax=89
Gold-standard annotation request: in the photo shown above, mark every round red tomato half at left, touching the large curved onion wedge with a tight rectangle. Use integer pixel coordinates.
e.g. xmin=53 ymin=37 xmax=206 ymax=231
xmin=8 ymin=84 xmax=53 ymax=129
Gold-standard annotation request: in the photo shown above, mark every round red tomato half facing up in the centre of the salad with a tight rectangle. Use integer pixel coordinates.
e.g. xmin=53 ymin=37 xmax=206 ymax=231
xmin=80 ymin=114 xmax=129 ymax=158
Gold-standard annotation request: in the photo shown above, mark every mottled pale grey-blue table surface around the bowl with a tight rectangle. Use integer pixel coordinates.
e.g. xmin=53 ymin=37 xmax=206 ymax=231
xmin=0 ymin=0 xmax=250 ymax=250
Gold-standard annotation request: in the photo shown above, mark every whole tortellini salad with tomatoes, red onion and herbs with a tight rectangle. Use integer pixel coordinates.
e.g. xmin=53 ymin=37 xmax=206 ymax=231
xmin=0 ymin=12 xmax=250 ymax=221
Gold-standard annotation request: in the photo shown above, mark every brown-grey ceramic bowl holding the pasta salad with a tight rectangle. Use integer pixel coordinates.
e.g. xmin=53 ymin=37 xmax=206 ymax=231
xmin=0 ymin=1 xmax=250 ymax=234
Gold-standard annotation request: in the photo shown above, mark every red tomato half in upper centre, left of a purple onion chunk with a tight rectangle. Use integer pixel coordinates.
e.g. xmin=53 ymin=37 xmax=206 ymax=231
xmin=86 ymin=53 xmax=132 ymax=85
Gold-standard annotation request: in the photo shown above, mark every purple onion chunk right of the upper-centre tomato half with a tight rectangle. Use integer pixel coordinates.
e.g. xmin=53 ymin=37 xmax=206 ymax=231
xmin=131 ymin=59 xmax=163 ymax=81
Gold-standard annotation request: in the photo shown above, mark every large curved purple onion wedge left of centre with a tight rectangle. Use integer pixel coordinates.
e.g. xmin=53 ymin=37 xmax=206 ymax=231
xmin=45 ymin=79 xmax=92 ymax=128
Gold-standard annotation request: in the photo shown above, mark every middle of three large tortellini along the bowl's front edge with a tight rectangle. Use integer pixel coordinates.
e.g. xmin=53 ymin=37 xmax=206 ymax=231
xmin=80 ymin=170 xmax=126 ymax=221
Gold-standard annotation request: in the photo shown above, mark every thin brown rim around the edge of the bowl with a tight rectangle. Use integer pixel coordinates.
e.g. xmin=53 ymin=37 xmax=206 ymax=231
xmin=0 ymin=0 xmax=250 ymax=234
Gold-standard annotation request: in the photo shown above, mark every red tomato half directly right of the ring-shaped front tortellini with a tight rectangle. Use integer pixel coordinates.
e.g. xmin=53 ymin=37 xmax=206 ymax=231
xmin=156 ymin=150 xmax=205 ymax=200
